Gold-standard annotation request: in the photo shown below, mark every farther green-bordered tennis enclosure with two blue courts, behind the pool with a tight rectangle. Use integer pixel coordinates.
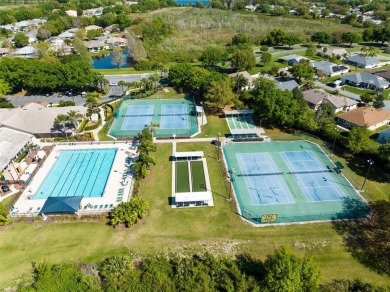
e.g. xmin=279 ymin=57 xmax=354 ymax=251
xmin=109 ymin=99 xmax=199 ymax=138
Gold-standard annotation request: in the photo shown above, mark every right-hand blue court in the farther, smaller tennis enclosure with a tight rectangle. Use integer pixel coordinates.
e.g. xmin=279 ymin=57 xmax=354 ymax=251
xmin=160 ymin=104 xmax=189 ymax=129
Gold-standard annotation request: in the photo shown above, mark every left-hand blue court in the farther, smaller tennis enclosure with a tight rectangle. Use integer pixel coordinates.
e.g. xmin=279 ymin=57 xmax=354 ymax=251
xmin=121 ymin=104 xmax=153 ymax=130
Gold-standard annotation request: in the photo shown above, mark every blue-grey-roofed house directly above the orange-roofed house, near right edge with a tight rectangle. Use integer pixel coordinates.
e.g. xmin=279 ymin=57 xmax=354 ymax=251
xmin=340 ymin=72 xmax=390 ymax=89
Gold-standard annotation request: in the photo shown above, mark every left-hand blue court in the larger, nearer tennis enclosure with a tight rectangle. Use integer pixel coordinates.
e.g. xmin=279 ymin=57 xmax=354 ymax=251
xmin=236 ymin=153 xmax=294 ymax=205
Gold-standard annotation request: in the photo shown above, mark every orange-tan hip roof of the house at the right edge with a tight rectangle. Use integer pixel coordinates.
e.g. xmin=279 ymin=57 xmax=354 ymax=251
xmin=338 ymin=107 xmax=390 ymax=127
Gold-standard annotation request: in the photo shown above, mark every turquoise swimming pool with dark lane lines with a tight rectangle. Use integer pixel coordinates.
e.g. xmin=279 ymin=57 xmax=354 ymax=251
xmin=33 ymin=148 xmax=117 ymax=200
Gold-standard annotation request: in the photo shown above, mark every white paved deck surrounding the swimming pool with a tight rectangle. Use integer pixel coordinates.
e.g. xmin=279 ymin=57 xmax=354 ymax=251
xmin=11 ymin=144 xmax=138 ymax=216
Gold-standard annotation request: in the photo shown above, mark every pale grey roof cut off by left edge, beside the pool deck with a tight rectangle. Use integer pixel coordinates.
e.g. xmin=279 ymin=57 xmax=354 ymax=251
xmin=0 ymin=127 xmax=32 ymax=170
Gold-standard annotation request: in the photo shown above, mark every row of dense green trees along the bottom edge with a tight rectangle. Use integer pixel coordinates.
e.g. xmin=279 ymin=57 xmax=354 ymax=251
xmin=18 ymin=247 xmax=386 ymax=292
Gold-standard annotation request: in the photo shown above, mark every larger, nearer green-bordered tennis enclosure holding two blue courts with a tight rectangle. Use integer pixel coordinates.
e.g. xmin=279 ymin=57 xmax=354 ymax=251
xmin=223 ymin=141 xmax=363 ymax=224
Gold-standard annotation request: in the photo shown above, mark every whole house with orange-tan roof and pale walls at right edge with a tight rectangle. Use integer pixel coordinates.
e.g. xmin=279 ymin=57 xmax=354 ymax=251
xmin=337 ymin=107 xmax=390 ymax=131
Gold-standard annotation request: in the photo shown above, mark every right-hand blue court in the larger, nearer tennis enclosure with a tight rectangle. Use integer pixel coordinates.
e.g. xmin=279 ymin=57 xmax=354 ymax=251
xmin=281 ymin=151 xmax=345 ymax=202
